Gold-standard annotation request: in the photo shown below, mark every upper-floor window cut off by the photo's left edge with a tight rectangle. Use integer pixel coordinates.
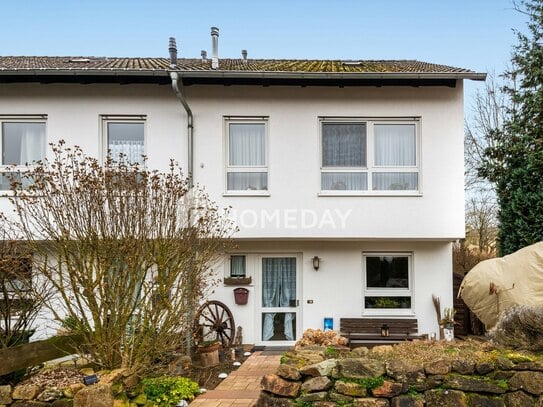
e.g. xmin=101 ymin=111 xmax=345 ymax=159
xmin=0 ymin=117 xmax=46 ymax=190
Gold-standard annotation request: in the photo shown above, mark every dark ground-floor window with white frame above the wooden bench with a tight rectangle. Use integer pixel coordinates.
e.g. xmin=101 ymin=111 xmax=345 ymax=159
xmin=363 ymin=253 xmax=413 ymax=314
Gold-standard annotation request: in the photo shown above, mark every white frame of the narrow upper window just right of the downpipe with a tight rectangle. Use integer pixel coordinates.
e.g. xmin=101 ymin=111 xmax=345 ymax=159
xmin=223 ymin=116 xmax=270 ymax=196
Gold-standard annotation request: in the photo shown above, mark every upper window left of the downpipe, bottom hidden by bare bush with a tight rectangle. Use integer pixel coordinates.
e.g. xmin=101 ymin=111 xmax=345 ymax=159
xmin=102 ymin=116 xmax=145 ymax=164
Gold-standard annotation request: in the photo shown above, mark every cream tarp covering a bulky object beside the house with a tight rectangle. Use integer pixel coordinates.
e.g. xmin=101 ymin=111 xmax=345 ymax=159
xmin=459 ymin=242 xmax=543 ymax=329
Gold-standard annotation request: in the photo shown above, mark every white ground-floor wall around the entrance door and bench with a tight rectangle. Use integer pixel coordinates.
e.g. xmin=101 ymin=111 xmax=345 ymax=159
xmin=212 ymin=241 xmax=453 ymax=343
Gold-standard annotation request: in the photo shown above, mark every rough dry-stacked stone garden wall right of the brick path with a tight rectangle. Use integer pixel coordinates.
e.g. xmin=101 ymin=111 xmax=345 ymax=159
xmin=258 ymin=347 xmax=543 ymax=407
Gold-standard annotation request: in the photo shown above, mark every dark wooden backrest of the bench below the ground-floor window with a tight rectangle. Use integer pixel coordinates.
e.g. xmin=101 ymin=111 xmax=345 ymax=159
xmin=339 ymin=318 xmax=418 ymax=335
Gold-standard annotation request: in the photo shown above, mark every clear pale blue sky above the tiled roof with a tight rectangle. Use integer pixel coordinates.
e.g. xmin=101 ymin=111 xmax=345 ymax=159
xmin=0 ymin=0 xmax=527 ymax=106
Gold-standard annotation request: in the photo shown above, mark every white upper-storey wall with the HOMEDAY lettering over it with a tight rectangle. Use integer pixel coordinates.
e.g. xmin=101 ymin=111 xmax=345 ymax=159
xmin=0 ymin=83 xmax=464 ymax=240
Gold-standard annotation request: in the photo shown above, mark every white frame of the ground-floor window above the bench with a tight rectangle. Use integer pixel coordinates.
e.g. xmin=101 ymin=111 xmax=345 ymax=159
xmin=362 ymin=252 xmax=415 ymax=316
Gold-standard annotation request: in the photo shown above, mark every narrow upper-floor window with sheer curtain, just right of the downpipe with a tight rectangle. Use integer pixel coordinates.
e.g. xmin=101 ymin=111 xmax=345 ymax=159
xmin=226 ymin=119 xmax=268 ymax=194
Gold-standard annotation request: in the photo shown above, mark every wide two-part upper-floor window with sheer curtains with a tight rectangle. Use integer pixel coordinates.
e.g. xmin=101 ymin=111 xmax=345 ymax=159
xmin=321 ymin=119 xmax=420 ymax=193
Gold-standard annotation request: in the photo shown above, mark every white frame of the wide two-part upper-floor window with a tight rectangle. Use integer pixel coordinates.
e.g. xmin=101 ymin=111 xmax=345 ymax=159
xmin=318 ymin=117 xmax=422 ymax=196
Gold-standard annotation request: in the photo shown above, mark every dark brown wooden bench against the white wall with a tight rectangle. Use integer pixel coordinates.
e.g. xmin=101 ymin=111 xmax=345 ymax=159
xmin=339 ymin=318 xmax=426 ymax=348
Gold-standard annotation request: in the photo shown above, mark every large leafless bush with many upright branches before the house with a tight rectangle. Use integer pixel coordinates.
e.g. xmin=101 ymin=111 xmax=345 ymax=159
xmin=6 ymin=142 xmax=234 ymax=372
